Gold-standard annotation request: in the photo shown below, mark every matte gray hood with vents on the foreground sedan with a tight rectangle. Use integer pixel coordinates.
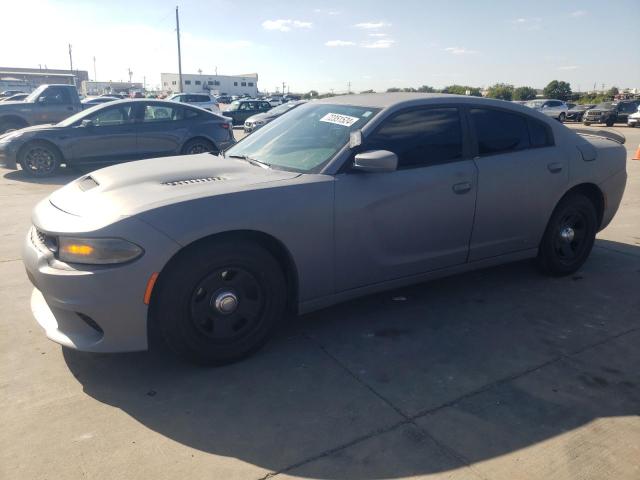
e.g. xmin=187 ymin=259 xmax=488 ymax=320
xmin=49 ymin=153 xmax=300 ymax=224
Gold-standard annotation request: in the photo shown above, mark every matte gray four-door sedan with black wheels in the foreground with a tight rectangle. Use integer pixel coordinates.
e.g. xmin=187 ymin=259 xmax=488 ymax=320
xmin=23 ymin=94 xmax=627 ymax=364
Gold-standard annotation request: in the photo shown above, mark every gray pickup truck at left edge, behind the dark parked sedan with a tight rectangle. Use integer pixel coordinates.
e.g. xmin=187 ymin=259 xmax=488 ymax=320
xmin=0 ymin=85 xmax=82 ymax=135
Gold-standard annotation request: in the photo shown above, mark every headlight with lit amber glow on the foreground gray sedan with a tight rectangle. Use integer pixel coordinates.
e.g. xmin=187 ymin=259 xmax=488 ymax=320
xmin=58 ymin=237 xmax=144 ymax=265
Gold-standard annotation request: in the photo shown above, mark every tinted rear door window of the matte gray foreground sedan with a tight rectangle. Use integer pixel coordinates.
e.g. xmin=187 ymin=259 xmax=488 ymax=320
xmin=469 ymin=108 xmax=531 ymax=155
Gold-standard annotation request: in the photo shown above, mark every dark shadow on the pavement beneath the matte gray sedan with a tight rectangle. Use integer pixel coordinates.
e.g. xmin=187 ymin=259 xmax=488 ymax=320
xmin=64 ymin=240 xmax=640 ymax=479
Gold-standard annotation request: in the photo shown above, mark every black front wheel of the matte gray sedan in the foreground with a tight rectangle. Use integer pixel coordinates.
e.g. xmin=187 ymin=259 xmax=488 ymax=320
xmin=152 ymin=241 xmax=287 ymax=365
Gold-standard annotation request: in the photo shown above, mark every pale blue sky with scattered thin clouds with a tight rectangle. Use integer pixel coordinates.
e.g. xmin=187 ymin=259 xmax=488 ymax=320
xmin=0 ymin=0 xmax=640 ymax=92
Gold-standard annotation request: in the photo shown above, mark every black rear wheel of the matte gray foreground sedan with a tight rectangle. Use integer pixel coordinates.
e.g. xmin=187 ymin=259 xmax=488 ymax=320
xmin=537 ymin=193 xmax=598 ymax=276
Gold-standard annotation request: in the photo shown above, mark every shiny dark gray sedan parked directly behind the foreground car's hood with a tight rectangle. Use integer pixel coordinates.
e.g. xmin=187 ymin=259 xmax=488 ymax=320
xmin=0 ymin=99 xmax=235 ymax=177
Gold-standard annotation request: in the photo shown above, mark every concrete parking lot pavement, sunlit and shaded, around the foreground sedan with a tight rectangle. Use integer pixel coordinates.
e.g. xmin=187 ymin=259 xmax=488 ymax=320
xmin=0 ymin=127 xmax=640 ymax=480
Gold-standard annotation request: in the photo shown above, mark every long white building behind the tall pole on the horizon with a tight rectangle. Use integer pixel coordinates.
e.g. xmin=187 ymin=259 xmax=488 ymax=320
xmin=160 ymin=73 xmax=258 ymax=97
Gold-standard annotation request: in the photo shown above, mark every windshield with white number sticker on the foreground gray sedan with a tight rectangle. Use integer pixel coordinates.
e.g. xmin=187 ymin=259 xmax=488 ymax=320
xmin=226 ymin=103 xmax=379 ymax=173
